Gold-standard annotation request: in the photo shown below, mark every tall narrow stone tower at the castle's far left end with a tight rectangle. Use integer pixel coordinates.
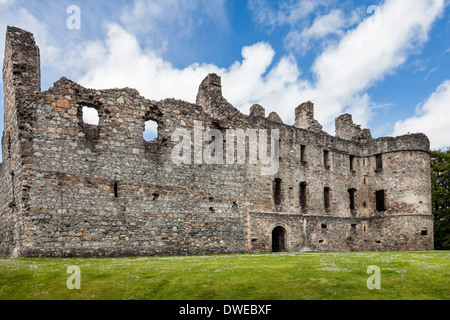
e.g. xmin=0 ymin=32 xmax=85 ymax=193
xmin=0 ymin=27 xmax=40 ymax=255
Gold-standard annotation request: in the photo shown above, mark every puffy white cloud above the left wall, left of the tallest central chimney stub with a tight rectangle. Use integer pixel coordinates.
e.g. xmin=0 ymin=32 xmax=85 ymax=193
xmin=79 ymin=24 xmax=223 ymax=101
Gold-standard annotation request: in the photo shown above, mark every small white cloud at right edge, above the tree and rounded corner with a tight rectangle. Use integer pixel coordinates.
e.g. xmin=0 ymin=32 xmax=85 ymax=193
xmin=393 ymin=80 xmax=450 ymax=149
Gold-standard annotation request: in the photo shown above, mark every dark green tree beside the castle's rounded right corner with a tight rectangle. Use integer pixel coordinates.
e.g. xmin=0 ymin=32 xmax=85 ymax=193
xmin=431 ymin=148 xmax=450 ymax=250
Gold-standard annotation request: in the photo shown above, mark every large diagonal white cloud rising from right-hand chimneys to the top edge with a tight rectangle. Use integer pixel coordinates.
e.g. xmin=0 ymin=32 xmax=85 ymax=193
xmin=312 ymin=0 xmax=444 ymax=131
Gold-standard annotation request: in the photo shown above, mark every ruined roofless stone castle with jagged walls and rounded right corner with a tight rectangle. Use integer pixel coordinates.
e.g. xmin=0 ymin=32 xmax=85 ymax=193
xmin=0 ymin=27 xmax=433 ymax=257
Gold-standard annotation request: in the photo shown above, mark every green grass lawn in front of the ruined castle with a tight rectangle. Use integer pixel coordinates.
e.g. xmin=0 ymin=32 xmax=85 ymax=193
xmin=0 ymin=251 xmax=450 ymax=300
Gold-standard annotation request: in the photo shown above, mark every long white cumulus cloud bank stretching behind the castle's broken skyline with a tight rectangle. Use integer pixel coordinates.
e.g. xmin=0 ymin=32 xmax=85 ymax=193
xmin=74 ymin=0 xmax=443 ymax=137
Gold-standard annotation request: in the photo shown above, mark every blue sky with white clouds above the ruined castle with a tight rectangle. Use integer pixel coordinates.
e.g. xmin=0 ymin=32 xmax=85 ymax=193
xmin=0 ymin=0 xmax=450 ymax=162
